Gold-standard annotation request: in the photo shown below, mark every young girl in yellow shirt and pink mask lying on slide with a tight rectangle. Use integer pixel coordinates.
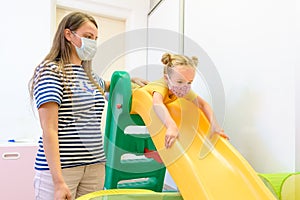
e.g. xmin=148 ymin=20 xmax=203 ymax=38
xmin=144 ymin=53 xmax=228 ymax=148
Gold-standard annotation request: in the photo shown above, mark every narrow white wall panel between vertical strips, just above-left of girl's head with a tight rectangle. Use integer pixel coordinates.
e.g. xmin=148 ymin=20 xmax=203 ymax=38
xmin=146 ymin=0 xmax=183 ymax=81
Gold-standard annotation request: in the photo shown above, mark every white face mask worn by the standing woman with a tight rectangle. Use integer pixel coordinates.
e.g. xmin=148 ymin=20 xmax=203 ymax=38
xmin=73 ymin=32 xmax=97 ymax=60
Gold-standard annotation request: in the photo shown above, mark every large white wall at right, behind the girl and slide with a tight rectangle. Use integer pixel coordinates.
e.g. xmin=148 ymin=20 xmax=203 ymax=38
xmin=184 ymin=0 xmax=299 ymax=172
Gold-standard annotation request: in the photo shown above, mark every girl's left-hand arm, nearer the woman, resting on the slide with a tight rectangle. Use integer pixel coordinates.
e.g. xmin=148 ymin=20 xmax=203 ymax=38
xmin=153 ymin=92 xmax=179 ymax=148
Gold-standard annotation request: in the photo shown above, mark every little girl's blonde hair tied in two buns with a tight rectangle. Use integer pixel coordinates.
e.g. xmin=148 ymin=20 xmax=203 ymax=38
xmin=161 ymin=53 xmax=198 ymax=75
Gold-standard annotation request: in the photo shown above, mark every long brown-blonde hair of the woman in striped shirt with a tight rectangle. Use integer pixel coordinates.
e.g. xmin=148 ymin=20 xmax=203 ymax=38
xmin=29 ymin=12 xmax=104 ymax=100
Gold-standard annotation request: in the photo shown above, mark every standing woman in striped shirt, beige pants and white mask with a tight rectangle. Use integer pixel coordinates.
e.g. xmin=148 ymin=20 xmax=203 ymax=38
xmin=30 ymin=12 xmax=145 ymax=200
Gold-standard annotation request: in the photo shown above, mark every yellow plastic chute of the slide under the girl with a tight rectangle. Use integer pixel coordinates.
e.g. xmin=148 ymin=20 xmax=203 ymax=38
xmin=131 ymin=88 xmax=276 ymax=200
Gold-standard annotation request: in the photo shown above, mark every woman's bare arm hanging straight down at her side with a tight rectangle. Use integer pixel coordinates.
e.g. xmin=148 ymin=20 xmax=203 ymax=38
xmin=38 ymin=102 xmax=71 ymax=200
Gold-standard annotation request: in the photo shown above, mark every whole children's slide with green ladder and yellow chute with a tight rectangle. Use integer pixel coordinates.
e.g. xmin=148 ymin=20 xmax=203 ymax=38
xmin=79 ymin=72 xmax=276 ymax=200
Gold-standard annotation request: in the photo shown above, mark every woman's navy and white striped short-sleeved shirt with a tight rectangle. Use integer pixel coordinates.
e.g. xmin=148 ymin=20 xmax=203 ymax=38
xmin=34 ymin=63 xmax=106 ymax=170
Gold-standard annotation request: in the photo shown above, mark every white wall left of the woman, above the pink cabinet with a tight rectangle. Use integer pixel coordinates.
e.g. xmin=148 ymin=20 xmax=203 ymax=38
xmin=0 ymin=0 xmax=53 ymax=141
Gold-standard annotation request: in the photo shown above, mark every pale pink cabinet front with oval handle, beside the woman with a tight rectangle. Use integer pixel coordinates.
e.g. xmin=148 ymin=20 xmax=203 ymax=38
xmin=0 ymin=146 xmax=37 ymax=200
